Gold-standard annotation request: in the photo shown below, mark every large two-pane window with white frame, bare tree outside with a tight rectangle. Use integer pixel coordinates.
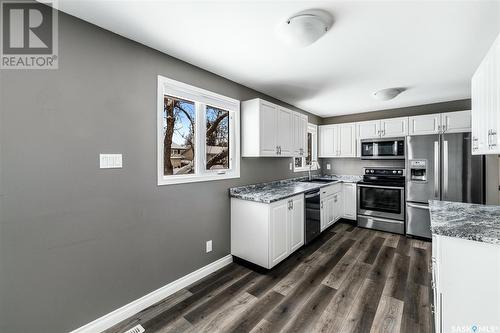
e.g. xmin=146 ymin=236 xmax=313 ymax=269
xmin=158 ymin=76 xmax=240 ymax=185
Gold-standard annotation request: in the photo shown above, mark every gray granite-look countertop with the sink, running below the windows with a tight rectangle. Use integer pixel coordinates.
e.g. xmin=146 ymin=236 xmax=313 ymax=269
xmin=229 ymin=175 xmax=362 ymax=203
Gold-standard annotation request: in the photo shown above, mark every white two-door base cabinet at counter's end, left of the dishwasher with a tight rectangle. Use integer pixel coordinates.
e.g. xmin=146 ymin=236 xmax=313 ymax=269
xmin=231 ymin=194 xmax=304 ymax=268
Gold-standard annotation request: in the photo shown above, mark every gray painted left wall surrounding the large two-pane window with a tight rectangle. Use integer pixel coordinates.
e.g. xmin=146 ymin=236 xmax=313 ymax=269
xmin=0 ymin=14 xmax=319 ymax=333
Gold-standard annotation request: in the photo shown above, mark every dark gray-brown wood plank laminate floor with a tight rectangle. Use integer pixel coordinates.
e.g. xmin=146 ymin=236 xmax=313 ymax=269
xmin=106 ymin=223 xmax=433 ymax=333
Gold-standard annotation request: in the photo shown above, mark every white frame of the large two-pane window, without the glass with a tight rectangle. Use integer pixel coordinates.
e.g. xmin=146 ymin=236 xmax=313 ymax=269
xmin=156 ymin=75 xmax=240 ymax=185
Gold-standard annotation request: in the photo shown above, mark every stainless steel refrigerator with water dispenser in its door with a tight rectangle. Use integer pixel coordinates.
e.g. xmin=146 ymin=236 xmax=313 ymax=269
xmin=406 ymin=133 xmax=484 ymax=238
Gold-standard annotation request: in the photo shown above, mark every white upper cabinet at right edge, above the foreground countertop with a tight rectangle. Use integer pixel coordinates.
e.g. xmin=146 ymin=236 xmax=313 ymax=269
xmin=472 ymin=35 xmax=500 ymax=155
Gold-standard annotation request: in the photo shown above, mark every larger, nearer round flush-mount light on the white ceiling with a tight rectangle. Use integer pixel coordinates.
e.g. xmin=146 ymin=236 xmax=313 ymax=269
xmin=278 ymin=10 xmax=332 ymax=47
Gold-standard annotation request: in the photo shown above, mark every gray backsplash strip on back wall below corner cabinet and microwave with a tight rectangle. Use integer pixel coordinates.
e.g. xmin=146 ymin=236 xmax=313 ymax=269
xmin=319 ymin=158 xmax=405 ymax=175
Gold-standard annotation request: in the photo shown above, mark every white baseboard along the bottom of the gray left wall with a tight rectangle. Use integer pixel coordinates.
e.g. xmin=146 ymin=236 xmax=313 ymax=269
xmin=71 ymin=254 xmax=233 ymax=333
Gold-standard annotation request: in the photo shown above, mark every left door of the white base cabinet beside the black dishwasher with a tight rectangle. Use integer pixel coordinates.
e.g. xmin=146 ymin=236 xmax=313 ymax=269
xmin=269 ymin=200 xmax=289 ymax=267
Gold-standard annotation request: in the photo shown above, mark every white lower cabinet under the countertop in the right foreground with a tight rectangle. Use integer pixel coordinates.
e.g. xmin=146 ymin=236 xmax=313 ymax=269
xmin=432 ymin=235 xmax=500 ymax=333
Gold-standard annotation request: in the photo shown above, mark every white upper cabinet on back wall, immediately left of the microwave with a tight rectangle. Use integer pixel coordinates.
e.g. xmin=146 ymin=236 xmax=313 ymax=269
xmin=318 ymin=123 xmax=356 ymax=157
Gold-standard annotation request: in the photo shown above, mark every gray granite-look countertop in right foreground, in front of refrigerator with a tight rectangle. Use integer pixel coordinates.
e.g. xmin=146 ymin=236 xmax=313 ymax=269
xmin=429 ymin=200 xmax=500 ymax=245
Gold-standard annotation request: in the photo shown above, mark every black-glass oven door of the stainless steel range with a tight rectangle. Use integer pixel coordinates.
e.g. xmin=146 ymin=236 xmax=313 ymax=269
xmin=358 ymin=184 xmax=405 ymax=221
